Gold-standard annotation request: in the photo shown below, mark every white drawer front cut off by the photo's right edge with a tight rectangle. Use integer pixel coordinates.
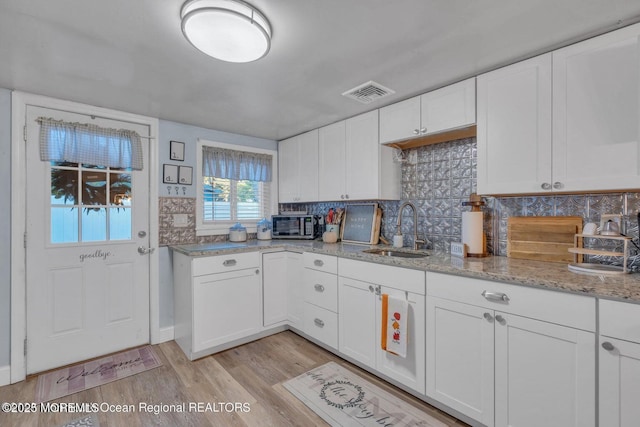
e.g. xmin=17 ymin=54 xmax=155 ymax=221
xmin=599 ymin=299 xmax=640 ymax=343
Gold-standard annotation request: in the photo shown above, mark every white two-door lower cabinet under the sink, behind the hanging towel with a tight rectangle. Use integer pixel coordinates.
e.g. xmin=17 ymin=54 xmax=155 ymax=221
xmin=338 ymin=259 xmax=425 ymax=394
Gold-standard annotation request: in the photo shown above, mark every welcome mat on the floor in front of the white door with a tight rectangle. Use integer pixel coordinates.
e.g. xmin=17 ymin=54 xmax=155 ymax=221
xmin=35 ymin=346 xmax=162 ymax=403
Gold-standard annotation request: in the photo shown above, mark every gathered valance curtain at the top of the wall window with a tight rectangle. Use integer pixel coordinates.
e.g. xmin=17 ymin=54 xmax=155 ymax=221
xmin=202 ymin=146 xmax=272 ymax=182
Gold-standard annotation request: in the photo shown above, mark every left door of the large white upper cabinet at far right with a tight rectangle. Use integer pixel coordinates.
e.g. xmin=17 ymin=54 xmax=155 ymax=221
xmin=477 ymin=54 xmax=552 ymax=194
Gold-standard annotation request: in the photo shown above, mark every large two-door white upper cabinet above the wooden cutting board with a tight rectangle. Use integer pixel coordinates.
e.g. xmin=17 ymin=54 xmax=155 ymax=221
xmin=477 ymin=24 xmax=640 ymax=194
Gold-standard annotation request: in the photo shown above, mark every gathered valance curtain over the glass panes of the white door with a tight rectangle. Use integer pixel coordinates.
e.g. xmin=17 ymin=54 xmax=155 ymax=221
xmin=36 ymin=117 xmax=143 ymax=170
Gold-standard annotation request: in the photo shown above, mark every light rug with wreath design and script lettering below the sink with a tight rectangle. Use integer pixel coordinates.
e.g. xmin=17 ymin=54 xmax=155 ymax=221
xmin=283 ymin=362 xmax=446 ymax=427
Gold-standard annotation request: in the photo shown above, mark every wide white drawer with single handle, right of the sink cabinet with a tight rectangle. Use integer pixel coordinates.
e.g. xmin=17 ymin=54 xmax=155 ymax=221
xmin=427 ymin=272 xmax=596 ymax=332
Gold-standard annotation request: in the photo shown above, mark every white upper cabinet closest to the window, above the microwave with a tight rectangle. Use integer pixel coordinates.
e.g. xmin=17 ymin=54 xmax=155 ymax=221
xmin=278 ymin=129 xmax=318 ymax=203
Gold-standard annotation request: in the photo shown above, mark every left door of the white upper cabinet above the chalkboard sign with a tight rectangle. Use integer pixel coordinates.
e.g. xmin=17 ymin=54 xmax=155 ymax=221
xmin=318 ymin=120 xmax=348 ymax=200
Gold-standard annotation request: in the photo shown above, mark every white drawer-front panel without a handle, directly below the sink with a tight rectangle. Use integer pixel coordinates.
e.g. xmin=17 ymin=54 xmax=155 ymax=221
xmin=338 ymin=258 xmax=425 ymax=295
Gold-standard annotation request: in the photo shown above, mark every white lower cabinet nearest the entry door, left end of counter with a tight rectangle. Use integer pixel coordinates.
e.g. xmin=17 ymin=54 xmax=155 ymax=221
xmin=173 ymin=252 xmax=262 ymax=360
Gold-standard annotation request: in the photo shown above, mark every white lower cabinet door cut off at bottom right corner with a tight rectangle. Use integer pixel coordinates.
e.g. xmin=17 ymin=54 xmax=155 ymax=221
xmin=599 ymin=337 xmax=640 ymax=427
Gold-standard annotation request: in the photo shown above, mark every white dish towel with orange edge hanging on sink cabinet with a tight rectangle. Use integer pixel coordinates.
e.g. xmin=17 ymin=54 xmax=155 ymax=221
xmin=381 ymin=294 xmax=409 ymax=357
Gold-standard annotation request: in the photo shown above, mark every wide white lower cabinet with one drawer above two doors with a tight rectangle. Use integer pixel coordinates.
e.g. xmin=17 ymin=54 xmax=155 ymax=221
xmin=427 ymin=273 xmax=596 ymax=427
